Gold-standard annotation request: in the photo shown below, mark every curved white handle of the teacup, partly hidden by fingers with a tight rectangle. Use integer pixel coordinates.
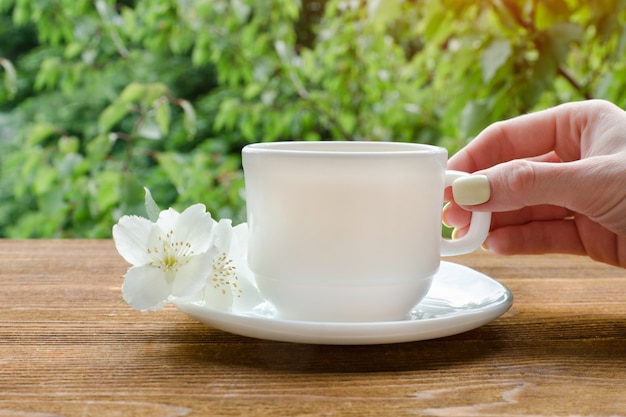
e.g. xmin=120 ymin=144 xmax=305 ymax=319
xmin=441 ymin=170 xmax=491 ymax=256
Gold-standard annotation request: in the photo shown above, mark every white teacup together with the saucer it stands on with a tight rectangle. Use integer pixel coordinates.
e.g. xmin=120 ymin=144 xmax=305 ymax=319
xmin=175 ymin=141 xmax=513 ymax=345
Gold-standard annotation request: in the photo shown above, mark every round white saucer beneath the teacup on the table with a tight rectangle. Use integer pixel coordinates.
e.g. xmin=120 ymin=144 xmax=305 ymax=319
xmin=175 ymin=262 xmax=513 ymax=345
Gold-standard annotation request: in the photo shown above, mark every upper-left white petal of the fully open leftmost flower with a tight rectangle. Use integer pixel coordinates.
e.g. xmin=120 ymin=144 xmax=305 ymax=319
xmin=113 ymin=216 xmax=155 ymax=266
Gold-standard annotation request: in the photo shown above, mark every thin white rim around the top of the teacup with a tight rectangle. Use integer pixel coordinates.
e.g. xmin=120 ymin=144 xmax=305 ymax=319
xmin=242 ymin=141 xmax=448 ymax=157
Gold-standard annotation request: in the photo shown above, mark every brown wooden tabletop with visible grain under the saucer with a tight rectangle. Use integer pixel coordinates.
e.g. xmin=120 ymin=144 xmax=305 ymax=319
xmin=0 ymin=240 xmax=626 ymax=417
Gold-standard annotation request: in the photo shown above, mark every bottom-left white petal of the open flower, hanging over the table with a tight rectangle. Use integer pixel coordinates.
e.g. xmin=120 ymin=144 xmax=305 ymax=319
xmin=122 ymin=266 xmax=171 ymax=311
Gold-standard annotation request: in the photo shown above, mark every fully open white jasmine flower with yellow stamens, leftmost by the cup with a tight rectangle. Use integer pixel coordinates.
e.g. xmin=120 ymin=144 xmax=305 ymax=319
xmin=113 ymin=204 xmax=216 ymax=310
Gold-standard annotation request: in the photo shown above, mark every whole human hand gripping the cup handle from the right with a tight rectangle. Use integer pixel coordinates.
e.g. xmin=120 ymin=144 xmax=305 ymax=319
xmin=444 ymin=100 xmax=626 ymax=267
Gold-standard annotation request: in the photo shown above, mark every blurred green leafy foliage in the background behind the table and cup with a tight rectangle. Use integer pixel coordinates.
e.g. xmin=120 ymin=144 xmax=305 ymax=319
xmin=0 ymin=0 xmax=626 ymax=237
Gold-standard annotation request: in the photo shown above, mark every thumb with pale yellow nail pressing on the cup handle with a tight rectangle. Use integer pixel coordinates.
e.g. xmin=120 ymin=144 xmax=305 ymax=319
xmin=452 ymin=156 xmax=626 ymax=220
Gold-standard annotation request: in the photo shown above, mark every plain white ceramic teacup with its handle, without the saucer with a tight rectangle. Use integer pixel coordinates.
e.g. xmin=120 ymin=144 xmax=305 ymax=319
xmin=242 ymin=142 xmax=491 ymax=322
